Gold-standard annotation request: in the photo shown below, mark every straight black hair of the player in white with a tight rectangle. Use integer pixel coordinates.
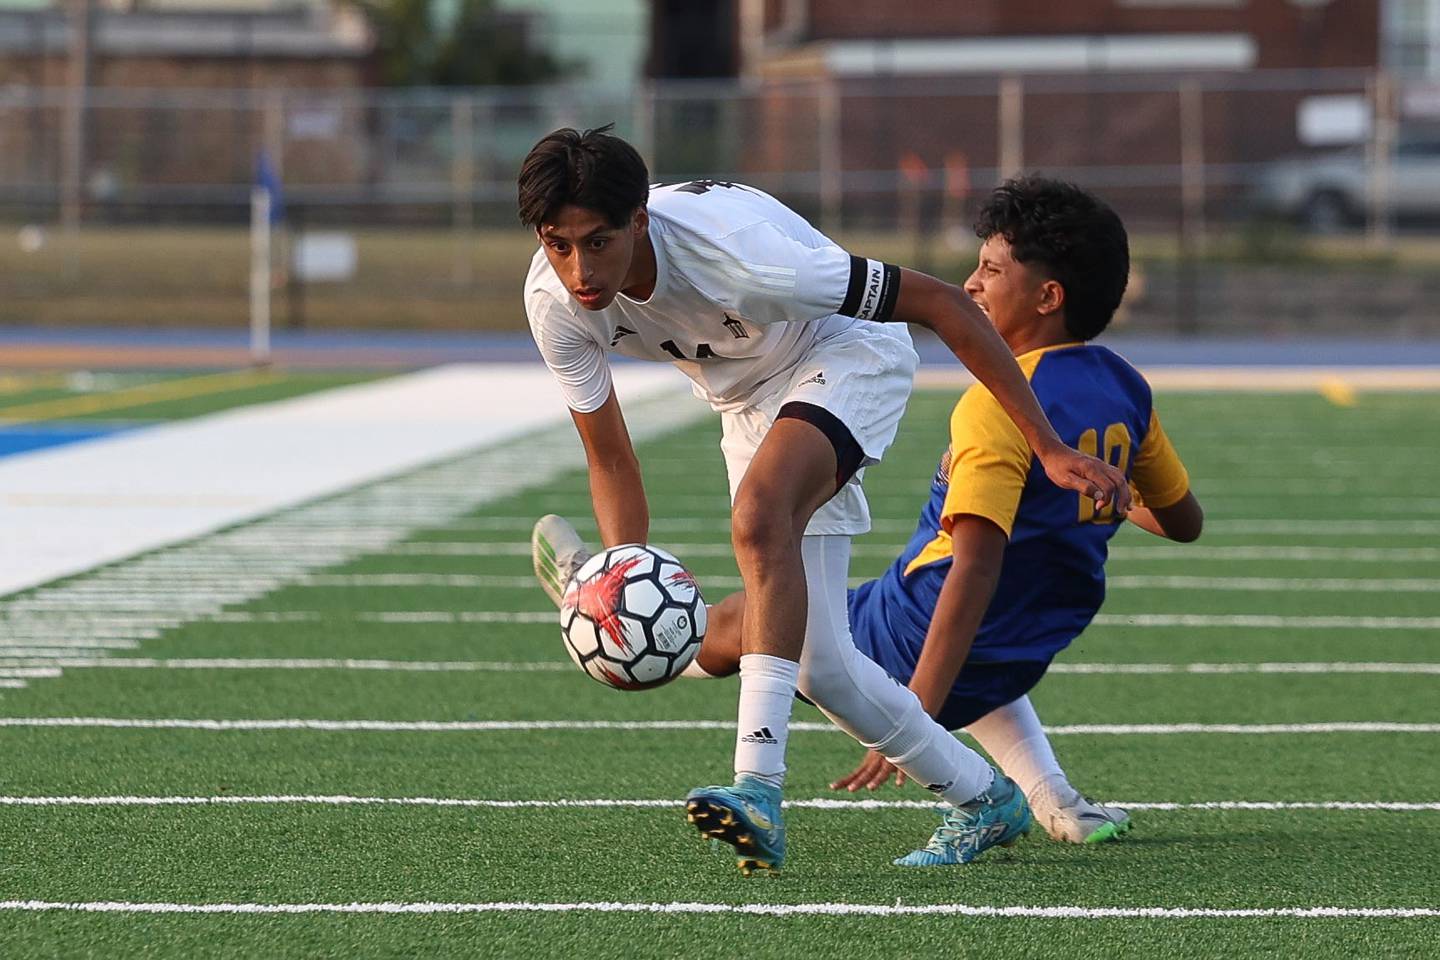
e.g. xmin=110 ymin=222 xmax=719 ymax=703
xmin=518 ymin=124 xmax=649 ymax=227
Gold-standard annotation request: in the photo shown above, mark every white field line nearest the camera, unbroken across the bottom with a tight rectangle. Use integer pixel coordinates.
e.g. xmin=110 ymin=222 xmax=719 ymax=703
xmin=0 ymin=900 xmax=1440 ymax=920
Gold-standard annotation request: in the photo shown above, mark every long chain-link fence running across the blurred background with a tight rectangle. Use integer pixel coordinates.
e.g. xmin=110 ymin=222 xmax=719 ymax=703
xmin=0 ymin=71 xmax=1440 ymax=332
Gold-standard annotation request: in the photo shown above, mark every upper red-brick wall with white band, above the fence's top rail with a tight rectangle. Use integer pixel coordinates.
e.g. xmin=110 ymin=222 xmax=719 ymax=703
xmin=740 ymin=0 xmax=1381 ymax=76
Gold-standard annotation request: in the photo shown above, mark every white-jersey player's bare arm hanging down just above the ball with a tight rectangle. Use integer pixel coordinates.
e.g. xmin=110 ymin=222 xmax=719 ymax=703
xmin=570 ymin=389 xmax=649 ymax=547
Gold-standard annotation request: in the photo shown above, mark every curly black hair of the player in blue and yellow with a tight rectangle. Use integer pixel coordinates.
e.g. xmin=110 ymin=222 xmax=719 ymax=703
xmin=975 ymin=177 xmax=1130 ymax=340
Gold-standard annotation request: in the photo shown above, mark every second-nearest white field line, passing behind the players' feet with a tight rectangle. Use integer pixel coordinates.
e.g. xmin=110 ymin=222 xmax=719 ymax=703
xmin=0 ymin=793 xmax=1440 ymax=813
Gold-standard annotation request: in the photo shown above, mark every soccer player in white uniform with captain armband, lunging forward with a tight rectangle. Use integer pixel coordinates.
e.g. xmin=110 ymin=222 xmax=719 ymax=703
xmin=518 ymin=128 xmax=1130 ymax=875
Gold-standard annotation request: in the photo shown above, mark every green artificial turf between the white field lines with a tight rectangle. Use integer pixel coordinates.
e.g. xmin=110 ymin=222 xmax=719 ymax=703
xmin=0 ymin=393 xmax=1440 ymax=959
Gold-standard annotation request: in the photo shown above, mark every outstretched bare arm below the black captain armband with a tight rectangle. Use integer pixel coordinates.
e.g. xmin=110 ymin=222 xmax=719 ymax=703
xmin=890 ymin=268 xmax=1130 ymax=515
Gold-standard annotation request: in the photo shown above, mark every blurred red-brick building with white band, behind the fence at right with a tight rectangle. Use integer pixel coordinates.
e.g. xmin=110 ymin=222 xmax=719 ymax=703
xmin=679 ymin=0 xmax=1381 ymax=217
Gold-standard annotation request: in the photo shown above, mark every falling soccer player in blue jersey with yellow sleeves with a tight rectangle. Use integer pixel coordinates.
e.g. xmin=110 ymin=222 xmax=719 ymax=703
xmin=685 ymin=178 xmax=1204 ymax=865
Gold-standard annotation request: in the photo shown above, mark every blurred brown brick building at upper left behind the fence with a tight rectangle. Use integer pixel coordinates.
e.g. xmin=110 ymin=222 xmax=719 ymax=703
xmin=0 ymin=4 xmax=374 ymax=209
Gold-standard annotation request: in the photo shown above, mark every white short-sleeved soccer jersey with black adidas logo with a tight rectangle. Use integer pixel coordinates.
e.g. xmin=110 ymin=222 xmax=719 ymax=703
xmin=526 ymin=180 xmax=899 ymax=413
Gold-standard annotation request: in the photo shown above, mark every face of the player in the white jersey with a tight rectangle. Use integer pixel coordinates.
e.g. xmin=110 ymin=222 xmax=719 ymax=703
xmin=536 ymin=204 xmax=649 ymax=309
